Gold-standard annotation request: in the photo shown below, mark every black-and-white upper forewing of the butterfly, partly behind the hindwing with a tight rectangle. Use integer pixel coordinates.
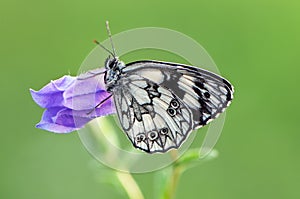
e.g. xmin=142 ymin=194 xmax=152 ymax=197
xmin=124 ymin=61 xmax=234 ymax=129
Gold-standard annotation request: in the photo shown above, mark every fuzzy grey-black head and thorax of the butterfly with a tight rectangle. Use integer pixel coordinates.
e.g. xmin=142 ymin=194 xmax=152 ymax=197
xmin=104 ymin=57 xmax=125 ymax=92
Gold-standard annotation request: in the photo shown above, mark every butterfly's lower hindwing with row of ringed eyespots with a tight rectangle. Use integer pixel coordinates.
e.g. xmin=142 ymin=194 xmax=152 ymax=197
xmin=114 ymin=74 xmax=193 ymax=153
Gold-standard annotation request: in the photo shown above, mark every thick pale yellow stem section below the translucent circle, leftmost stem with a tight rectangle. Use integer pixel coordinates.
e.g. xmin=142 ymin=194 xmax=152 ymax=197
xmin=116 ymin=171 xmax=144 ymax=199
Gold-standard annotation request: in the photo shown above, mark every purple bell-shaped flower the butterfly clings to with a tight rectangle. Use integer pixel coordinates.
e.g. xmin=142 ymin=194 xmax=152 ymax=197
xmin=30 ymin=69 xmax=115 ymax=133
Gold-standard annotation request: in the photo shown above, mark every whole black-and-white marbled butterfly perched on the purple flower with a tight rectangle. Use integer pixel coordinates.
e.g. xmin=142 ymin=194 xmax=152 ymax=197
xmin=82 ymin=22 xmax=234 ymax=153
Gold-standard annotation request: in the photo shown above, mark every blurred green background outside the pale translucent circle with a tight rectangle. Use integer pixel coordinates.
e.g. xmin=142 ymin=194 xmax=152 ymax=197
xmin=0 ymin=0 xmax=300 ymax=199
